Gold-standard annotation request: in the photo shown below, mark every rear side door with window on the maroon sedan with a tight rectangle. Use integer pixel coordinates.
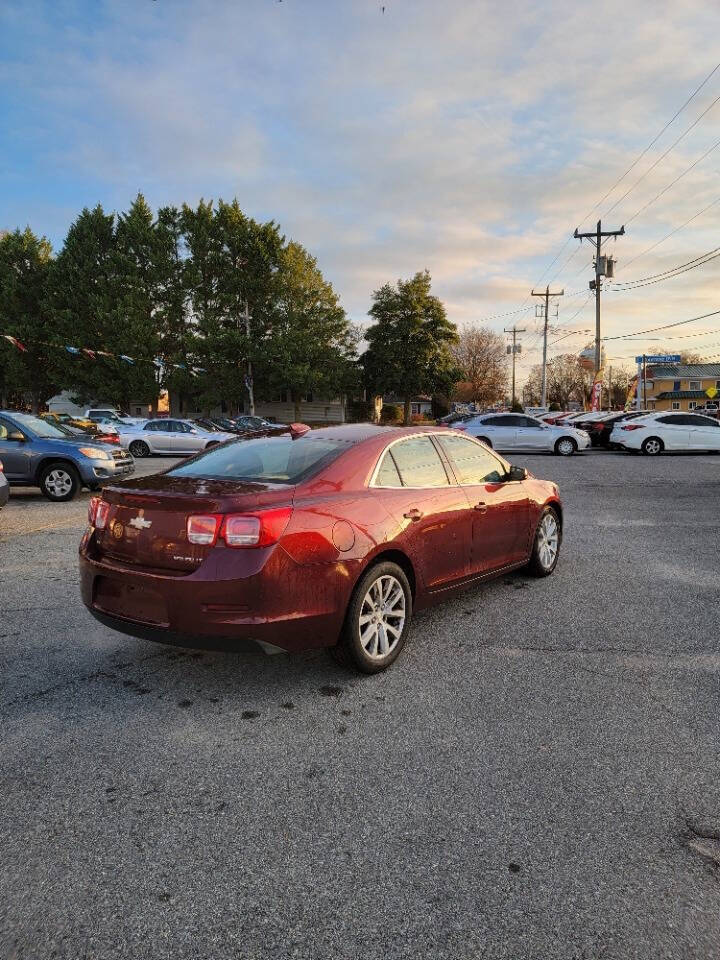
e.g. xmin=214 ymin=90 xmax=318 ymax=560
xmin=371 ymin=434 xmax=472 ymax=590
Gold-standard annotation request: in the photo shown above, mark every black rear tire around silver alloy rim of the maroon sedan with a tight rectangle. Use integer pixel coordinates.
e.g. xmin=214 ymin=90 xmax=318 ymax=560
xmin=332 ymin=561 xmax=412 ymax=673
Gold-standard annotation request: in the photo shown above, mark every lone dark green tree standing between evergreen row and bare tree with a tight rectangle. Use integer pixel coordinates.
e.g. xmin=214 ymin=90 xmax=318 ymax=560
xmin=362 ymin=270 xmax=461 ymax=424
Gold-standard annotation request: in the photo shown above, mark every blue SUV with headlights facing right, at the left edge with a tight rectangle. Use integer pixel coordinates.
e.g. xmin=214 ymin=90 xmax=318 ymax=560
xmin=0 ymin=410 xmax=135 ymax=501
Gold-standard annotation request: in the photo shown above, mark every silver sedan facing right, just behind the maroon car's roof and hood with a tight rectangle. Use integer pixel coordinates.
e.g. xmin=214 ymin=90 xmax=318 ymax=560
xmin=455 ymin=413 xmax=590 ymax=457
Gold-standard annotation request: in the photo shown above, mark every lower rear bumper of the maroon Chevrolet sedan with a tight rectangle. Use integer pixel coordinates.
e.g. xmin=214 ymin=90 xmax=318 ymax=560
xmin=80 ymin=531 xmax=350 ymax=651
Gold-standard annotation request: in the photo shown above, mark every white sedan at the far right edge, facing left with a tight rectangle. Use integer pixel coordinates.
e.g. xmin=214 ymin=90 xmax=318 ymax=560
xmin=610 ymin=411 xmax=720 ymax=457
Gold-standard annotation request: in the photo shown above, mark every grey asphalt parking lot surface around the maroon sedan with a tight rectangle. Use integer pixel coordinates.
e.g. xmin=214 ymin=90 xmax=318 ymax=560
xmin=0 ymin=452 xmax=720 ymax=960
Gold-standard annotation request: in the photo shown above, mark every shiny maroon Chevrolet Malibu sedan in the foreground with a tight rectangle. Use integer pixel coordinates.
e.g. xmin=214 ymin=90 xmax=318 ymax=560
xmin=80 ymin=424 xmax=562 ymax=673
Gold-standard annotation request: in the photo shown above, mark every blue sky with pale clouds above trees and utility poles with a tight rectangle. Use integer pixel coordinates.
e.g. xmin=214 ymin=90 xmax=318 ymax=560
xmin=0 ymin=0 xmax=720 ymax=382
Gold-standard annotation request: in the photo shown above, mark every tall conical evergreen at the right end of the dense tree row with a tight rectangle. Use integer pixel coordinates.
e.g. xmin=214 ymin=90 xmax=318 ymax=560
xmin=256 ymin=242 xmax=357 ymax=420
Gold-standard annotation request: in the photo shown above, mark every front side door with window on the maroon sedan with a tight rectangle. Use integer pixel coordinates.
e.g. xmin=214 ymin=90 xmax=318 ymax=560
xmin=437 ymin=434 xmax=530 ymax=576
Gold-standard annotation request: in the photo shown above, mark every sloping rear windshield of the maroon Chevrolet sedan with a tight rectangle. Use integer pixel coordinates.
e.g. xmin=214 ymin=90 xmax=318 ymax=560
xmin=168 ymin=434 xmax=348 ymax=483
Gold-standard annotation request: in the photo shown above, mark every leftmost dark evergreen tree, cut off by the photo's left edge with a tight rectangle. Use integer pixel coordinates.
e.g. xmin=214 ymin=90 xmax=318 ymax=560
xmin=0 ymin=233 xmax=61 ymax=413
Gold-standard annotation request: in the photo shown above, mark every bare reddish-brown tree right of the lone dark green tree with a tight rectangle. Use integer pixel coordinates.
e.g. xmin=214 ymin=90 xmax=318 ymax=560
xmin=452 ymin=326 xmax=508 ymax=407
